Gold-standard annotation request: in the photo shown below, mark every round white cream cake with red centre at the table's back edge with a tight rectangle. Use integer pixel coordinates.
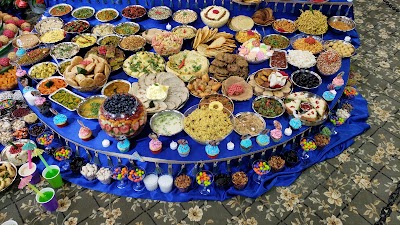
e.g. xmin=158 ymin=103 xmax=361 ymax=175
xmin=200 ymin=5 xmax=230 ymax=28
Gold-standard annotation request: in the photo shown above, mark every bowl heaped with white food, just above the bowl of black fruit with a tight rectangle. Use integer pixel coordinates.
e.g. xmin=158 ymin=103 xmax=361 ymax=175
xmin=287 ymin=50 xmax=317 ymax=69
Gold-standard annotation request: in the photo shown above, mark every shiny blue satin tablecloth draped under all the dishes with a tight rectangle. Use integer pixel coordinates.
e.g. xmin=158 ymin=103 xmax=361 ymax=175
xmin=3 ymin=0 xmax=369 ymax=201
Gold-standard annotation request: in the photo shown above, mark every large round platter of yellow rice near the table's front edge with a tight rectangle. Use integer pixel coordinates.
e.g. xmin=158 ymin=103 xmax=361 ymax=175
xmin=183 ymin=102 xmax=235 ymax=145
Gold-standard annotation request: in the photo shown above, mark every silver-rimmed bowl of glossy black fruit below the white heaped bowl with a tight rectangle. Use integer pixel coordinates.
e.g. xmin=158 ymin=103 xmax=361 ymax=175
xmin=290 ymin=69 xmax=322 ymax=90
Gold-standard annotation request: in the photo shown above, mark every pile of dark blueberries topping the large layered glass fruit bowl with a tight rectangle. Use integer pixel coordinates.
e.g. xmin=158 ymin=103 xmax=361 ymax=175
xmin=104 ymin=94 xmax=137 ymax=115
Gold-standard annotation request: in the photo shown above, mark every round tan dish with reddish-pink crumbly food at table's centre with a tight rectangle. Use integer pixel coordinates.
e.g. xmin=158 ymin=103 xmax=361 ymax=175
xmin=222 ymin=76 xmax=253 ymax=101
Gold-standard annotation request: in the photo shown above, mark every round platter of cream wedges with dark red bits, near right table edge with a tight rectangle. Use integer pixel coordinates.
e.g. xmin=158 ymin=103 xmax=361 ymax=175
xmin=284 ymin=91 xmax=329 ymax=126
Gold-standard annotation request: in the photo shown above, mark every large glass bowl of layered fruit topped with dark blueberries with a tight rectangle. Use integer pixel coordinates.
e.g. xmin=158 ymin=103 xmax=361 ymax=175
xmin=99 ymin=94 xmax=147 ymax=140
